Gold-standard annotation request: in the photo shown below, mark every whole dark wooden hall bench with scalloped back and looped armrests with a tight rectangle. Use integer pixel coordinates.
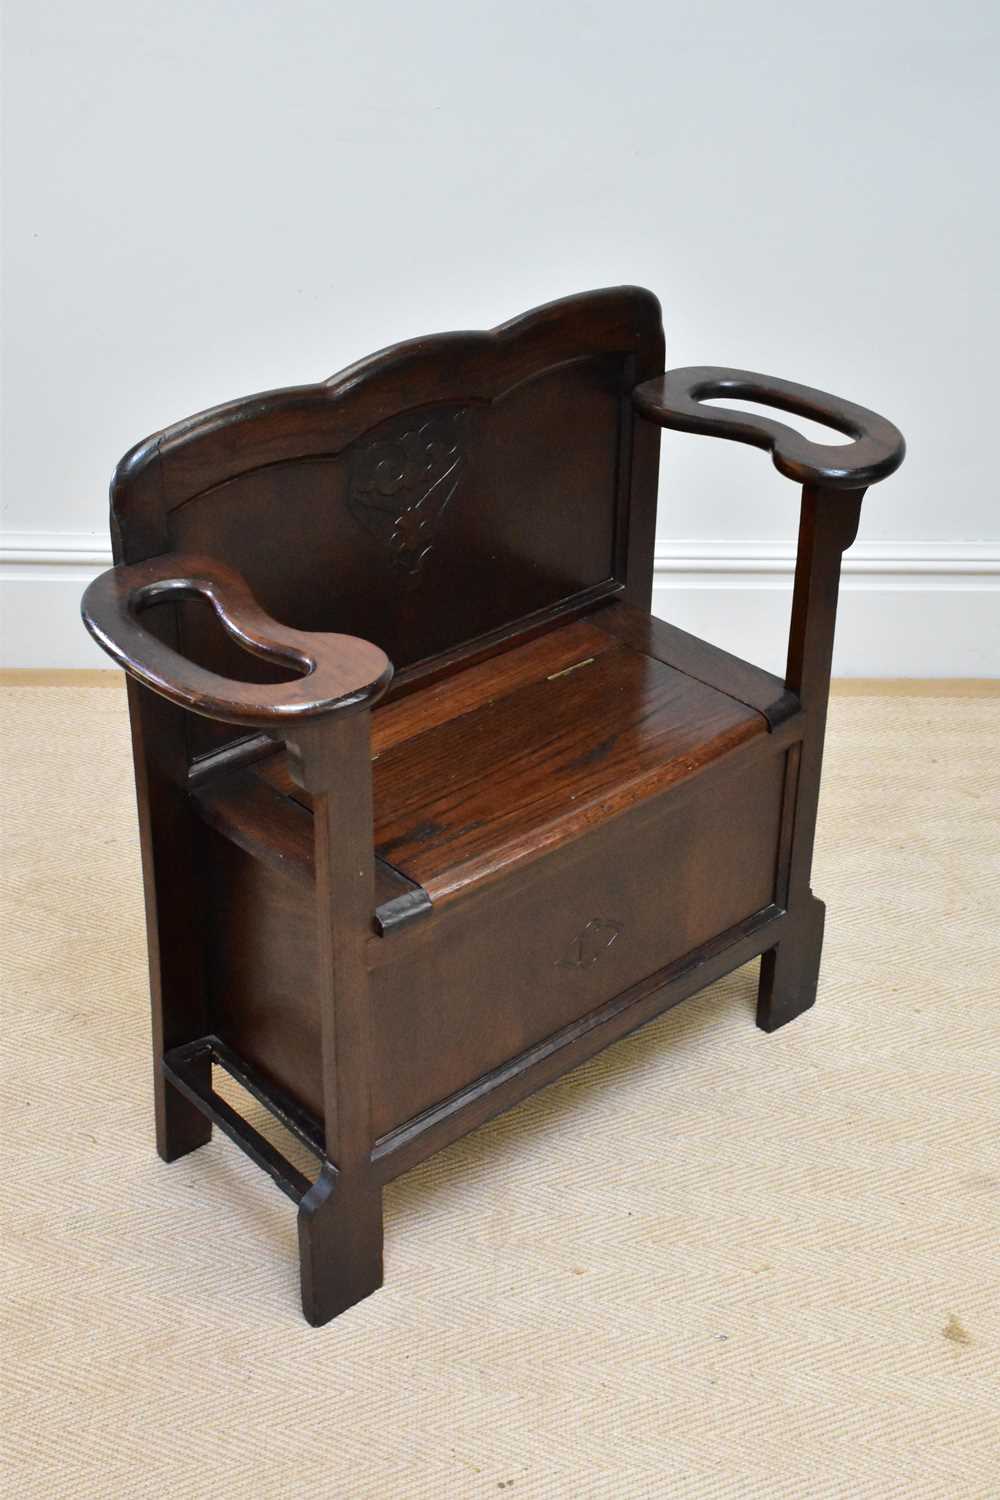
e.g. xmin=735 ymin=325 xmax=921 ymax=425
xmin=84 ymin=288 xmax=903 ymax=1323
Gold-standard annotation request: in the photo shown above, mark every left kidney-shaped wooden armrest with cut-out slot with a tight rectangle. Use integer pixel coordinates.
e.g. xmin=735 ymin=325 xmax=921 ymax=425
xmin=82 ymin=554 xmax=393 ymax=729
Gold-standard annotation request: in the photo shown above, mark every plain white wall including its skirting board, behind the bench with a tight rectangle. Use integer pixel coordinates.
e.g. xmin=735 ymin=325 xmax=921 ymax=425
xmin=1 ymin=0 xmax=1000 ymax=675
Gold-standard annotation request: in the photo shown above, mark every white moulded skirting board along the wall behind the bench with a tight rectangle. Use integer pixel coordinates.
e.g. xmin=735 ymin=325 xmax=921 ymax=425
xmin=0 ymin=533 xmax=1000 ymax=677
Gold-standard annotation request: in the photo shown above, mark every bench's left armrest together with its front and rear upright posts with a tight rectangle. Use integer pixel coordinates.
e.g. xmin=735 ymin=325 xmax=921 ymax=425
xmin=82 ymin=555 xmax=393 ymax=1302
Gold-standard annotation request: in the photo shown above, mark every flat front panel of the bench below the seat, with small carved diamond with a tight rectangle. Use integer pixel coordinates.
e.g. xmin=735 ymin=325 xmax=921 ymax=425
xmin=371 ymin=756 xmax=783 ymax=1137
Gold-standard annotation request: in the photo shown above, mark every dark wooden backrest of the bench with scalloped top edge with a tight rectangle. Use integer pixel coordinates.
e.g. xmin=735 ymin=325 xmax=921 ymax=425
xmin=112 ymin=288 xmax=663 ymax=740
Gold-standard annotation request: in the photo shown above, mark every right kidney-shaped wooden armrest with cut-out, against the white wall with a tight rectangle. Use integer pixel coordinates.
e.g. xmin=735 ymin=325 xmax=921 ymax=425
xmin=633 ymin=365 xmax=906 ymax=489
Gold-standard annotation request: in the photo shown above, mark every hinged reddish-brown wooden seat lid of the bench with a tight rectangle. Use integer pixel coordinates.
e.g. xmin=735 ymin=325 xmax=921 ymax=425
xmin=246 ymin=612 xmax=766 ymax=906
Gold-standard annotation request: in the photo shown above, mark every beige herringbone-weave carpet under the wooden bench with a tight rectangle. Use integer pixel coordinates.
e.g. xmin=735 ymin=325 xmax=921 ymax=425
xmin=1 ymin=687 xmax=1000 ymax=1500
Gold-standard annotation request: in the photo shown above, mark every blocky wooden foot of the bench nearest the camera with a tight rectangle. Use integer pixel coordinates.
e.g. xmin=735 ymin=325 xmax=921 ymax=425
xmin=298 ymin=1164 xmax=382 ymax=1328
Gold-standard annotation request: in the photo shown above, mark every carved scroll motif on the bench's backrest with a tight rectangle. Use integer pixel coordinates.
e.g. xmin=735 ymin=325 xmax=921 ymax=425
xmin=348 ymin=408 xmax=466 ymax=581
